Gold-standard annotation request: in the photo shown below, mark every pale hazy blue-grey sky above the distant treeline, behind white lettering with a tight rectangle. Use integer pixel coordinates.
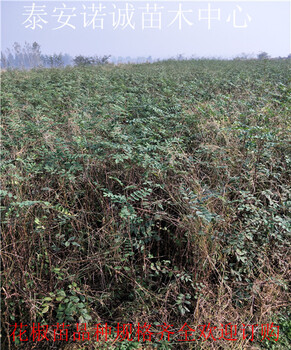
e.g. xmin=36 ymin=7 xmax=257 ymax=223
xmin=1 ymin=0 xmax=291 ymax=58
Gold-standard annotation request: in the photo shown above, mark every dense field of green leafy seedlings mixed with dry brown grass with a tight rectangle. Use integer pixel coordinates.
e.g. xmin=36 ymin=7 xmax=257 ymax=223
xmin=0 ymin=60 xmax=291 ymax=350
